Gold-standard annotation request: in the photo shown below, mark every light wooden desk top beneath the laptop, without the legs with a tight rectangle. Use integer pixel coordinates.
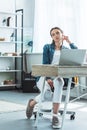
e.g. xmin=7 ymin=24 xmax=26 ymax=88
xmin=32 ymin=64 xmax=87 ymax=77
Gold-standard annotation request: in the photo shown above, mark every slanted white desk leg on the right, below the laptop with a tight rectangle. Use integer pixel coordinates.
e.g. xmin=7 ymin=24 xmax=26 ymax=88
xmin=61 ymin=78 xmax=72 ymax=130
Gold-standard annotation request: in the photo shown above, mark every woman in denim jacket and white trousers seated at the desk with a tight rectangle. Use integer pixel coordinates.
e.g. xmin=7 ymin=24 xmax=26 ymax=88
xmin=26 ymin=27 xmax=77 ymax=128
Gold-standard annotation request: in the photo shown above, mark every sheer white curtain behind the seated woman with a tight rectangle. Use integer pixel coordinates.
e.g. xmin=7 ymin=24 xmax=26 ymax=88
xmin=33 ymin=0 xmax=87 ymax=52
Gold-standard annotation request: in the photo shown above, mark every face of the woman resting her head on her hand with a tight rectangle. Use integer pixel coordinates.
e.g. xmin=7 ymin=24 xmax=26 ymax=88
xmin=51 ymin=29 xmax=63 ymax=43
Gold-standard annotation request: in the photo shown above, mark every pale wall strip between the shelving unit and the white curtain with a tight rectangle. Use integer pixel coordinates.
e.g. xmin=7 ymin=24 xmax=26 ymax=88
xmin=16 ymin=0 xmax=35 ymax=51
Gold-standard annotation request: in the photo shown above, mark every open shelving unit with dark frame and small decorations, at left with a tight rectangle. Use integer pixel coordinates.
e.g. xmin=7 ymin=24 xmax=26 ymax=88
xmin=0 ymin=10 xmax=23 ymax=88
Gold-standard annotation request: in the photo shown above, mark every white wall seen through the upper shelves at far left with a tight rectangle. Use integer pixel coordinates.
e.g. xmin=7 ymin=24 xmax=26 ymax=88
xmin=0 ymin=0 xmax=15 ymax=53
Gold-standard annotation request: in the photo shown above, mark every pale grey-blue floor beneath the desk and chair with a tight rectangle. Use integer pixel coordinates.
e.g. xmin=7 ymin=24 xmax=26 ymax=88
xmin=0 ymin=90 xmax=87 ymax=130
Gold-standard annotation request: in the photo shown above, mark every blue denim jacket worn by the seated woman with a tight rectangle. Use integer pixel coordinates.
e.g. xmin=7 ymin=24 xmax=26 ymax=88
xmin=43 ymin=43 xmax=77 ymax=64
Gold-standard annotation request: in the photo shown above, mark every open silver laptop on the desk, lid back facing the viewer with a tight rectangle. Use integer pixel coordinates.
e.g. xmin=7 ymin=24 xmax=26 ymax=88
xmin=59 ymin=49 xmax=86 ymax=66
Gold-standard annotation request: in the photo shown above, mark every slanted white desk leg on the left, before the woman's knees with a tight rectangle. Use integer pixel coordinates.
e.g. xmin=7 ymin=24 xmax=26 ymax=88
xmin=35 ymin=77 xmax=46 ymax=127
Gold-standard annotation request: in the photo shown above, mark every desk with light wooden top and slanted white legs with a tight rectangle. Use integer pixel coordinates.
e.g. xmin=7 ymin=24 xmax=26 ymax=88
xmin=32 ymin=64 xmax=87 ymax=130
